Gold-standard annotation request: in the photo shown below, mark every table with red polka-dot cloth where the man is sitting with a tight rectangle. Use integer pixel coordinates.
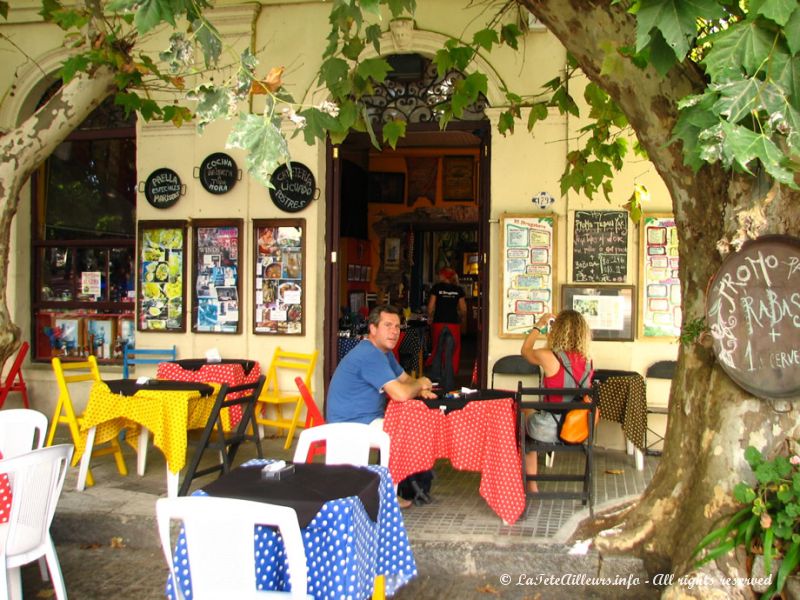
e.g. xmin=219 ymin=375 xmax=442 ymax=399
xmin=383 ymin=390 xmax=526 ymax=525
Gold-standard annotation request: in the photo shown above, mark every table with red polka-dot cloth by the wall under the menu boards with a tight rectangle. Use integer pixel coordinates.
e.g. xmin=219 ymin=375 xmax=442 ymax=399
xmin=156 ymin=358 xmax=261 ymax=431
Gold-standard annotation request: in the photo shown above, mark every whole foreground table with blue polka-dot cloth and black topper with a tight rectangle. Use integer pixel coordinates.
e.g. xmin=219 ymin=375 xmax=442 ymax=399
xmin=167 ymin=459 xmax=417 ymax=600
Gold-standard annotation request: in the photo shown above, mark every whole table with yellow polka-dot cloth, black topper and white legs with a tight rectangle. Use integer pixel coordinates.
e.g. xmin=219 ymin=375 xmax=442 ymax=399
xmin=75 ymin=379 xmax=219 ymax=498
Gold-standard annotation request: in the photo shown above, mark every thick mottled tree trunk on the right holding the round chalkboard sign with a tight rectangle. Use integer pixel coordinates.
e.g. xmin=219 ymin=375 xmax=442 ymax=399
xmin=521 ymin=0 xmax=800 ymax=597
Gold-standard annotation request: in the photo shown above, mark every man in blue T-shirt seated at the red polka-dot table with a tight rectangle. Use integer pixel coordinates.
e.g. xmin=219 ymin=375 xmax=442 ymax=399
xmin=326 ymin=304 xmax=436 ymax=424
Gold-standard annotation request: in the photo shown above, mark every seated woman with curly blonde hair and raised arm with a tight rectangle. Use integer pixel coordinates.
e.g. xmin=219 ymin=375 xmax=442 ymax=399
xmin=521 ymin=310 xmax=592 ymax=493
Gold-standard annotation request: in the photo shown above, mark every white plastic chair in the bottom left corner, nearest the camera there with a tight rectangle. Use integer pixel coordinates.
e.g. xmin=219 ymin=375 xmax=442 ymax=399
xmin=0 ymin=444 xmax=73 ymax=600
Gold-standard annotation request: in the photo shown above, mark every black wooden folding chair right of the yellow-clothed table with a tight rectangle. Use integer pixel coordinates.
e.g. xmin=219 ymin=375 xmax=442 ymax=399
xmin=178 ymin=375 xmax=266 ymax=496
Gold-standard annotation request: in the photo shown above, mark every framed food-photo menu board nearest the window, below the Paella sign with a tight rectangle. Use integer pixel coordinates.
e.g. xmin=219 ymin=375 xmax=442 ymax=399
xmin=136 ymin=221 xmax=186 ymax=332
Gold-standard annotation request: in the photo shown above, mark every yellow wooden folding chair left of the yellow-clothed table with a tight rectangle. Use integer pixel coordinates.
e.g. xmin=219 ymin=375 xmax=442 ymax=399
xmin=47 ymin=356 xmax=128 ymax=485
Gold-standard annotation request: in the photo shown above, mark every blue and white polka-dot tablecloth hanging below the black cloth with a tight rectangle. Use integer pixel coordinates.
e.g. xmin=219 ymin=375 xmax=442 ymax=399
xmin=166 ymin=459 xmax=417 ymax=600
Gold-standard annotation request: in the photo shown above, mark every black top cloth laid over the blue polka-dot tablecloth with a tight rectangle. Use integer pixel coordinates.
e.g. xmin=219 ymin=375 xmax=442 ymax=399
xmin=202 ymin=463 xmax=381 ymax=528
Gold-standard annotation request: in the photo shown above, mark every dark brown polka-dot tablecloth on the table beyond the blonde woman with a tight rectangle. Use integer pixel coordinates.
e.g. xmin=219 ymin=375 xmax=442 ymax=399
xmin=599 ymin=373 xmax=647 ymax=450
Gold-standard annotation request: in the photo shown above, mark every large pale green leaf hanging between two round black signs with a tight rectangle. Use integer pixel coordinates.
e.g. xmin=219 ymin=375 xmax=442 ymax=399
xmin=226 ymin=114 xmax=290 ymax=187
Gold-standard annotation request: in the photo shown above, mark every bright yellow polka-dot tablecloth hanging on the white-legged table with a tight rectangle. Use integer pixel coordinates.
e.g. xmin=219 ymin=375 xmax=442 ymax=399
xmin=75 ymin=381 xmax=219 ymax=473
